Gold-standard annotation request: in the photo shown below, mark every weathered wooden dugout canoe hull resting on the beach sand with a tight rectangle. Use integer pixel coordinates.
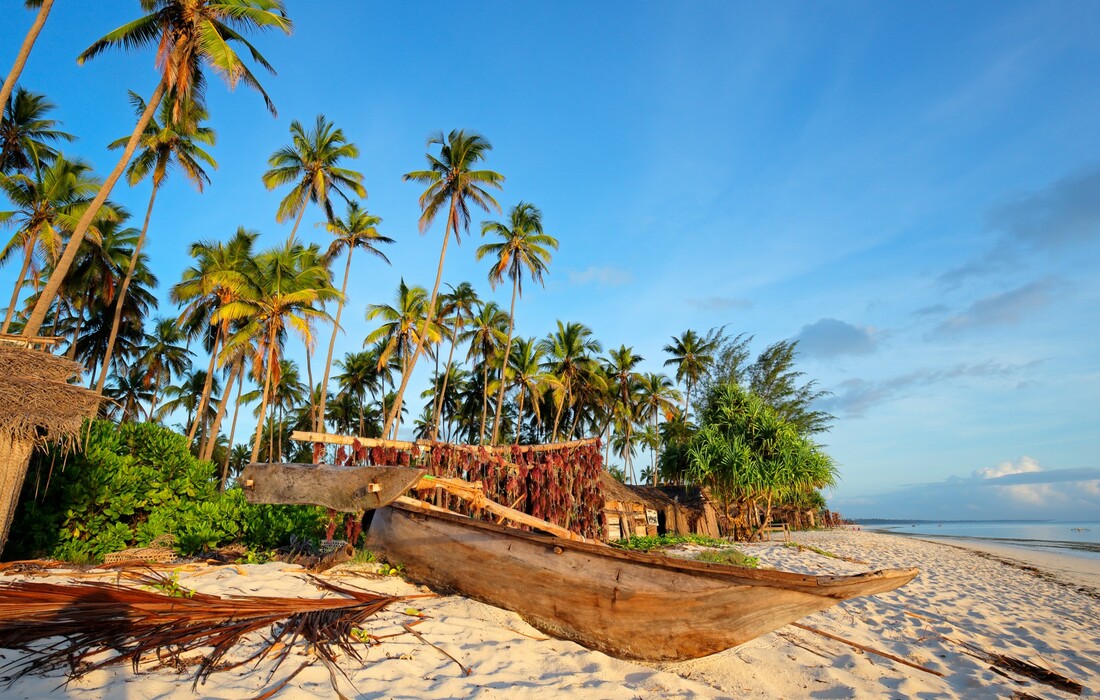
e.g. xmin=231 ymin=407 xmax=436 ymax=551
xmin=366 ymin=503 xmax=917 ymax=661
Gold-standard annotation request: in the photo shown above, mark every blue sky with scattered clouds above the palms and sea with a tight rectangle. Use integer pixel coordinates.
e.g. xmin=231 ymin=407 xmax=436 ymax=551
xmin=0 ymin=0 xmax=1100 ymax=518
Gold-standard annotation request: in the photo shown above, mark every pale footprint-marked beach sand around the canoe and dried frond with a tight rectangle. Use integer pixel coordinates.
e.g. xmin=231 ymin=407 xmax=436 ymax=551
xmin=0 ymin=531 xmax=1100 ymax=700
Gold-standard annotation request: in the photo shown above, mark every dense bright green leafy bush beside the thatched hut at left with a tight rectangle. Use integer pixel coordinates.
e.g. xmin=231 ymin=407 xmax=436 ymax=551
xmin=4 ymin=420 xmax=328 ymax=562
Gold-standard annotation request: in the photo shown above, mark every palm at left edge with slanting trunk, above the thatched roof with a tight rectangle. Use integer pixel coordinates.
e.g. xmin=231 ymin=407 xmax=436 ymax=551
xmin=0 ymin=154 xmax=120 ymax=332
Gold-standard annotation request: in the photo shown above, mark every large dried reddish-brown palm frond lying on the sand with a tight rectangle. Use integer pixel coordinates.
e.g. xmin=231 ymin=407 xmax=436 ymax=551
xmin=0 ymin=573 xmax=403 ymax=698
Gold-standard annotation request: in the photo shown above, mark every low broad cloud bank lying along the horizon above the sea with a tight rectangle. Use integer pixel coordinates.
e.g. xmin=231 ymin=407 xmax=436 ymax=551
xmin=835 ymin=456 xmax=1100 ymax=519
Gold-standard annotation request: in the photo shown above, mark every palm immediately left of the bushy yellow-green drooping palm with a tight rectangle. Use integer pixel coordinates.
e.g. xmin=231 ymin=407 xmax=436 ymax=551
xmin=169 ymin=227 xmax=260 ymax=439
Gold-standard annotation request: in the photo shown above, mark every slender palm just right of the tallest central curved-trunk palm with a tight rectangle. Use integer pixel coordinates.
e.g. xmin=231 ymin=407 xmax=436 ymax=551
xmin=477 ymin=201 xmax=558 ymax=445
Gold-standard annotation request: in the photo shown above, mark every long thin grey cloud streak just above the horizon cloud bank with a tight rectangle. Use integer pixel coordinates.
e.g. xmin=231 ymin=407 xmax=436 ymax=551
xmin=818 ymin=361 xmax=1035 ymax=417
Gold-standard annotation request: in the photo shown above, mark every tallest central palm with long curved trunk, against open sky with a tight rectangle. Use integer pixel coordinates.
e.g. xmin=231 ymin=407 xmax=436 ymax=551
xmin=383 ymin=129 xmax=504 ymax=434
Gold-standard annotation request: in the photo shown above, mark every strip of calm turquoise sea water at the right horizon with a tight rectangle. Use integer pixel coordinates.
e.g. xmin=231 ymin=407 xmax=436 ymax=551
xmin=864 ymin=521 xmax=1100 ymax=559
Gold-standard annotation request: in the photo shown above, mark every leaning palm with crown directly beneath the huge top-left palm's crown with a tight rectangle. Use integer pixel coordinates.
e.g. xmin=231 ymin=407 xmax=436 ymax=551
xmin=96 ymin=91 xmax=218 ymax=394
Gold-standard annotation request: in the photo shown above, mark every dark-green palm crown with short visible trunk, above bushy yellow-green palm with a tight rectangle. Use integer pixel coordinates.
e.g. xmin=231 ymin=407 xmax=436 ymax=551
xmin=263 ymin=114 xmax=366 ymax=244
